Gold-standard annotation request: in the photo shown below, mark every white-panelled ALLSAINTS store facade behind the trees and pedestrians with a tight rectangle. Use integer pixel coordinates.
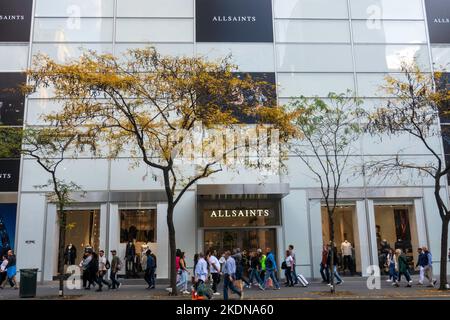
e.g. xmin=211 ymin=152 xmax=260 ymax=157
xmin=0 ymin=0 xmax=450 ymax=280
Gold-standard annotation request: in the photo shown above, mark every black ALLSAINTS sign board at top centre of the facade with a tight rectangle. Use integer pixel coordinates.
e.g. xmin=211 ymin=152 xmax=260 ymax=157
xmin=196 ymin=0 xmax=273 ymax=42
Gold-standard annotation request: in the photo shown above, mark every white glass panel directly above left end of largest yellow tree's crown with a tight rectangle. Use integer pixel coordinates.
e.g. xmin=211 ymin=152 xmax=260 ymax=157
xmin=33 ymin=43 xmax=112 ymax=63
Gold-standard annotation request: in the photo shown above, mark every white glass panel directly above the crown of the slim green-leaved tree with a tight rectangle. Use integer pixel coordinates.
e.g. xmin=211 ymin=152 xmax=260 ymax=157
xmin=278 ymin=73 xmax=354 ymax=98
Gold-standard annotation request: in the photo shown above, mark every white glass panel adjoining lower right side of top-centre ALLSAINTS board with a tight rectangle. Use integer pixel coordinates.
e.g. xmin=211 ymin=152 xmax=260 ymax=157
xmin=275 ymin=20 xmax=350 ymax=43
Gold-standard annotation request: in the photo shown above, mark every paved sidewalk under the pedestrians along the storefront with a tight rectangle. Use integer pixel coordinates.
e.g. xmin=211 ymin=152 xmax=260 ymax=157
xmin=0 ymin=277 xmax=450 ymax=300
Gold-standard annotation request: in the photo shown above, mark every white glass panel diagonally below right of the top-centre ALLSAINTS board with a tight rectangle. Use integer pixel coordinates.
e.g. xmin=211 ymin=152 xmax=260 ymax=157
xmin=277 ymin=44 xmax=353 ymax=72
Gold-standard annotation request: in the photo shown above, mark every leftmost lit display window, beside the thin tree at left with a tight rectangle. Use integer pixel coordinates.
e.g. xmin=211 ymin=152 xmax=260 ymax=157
xmin=58 ymin=209 xmax=100 ymax=274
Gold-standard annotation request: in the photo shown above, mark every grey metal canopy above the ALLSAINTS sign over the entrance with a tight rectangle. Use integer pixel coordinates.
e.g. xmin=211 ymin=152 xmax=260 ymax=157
xmin=197 ymin=183 xmax=289 ymax=199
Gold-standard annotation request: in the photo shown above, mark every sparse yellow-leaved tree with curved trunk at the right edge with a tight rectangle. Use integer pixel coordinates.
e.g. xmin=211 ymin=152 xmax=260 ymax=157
xmin=368 ymin=62 xmax=450 ymax=290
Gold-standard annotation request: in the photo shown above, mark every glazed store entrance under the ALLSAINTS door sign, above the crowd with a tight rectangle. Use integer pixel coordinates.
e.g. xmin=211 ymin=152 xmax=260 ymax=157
xmin=204 ymin=228 xmax=277 ymax=254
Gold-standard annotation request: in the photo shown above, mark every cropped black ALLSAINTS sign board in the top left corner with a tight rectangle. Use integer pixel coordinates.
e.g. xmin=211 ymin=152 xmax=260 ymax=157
xmin=0 ymin=0 xmax=33 ymax=42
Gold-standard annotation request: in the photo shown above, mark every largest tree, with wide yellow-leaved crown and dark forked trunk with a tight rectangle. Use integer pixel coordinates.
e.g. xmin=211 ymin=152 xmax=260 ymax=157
xmin=28 ymin=48 xmax=287 ymax=294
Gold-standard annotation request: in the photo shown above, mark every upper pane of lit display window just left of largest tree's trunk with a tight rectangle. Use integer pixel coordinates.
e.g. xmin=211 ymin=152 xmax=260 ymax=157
xmin=120 ymin=209 xmax=156 ymax=243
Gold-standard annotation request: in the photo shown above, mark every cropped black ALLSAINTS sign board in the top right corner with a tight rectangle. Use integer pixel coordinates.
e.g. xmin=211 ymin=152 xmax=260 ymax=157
xmin=425 ymin=0 xmax=450 ymax=43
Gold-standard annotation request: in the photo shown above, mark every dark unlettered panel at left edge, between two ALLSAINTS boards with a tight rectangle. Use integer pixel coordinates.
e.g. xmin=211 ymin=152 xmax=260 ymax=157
xmin=0 ymin=73 xmax=26 ymax=125
